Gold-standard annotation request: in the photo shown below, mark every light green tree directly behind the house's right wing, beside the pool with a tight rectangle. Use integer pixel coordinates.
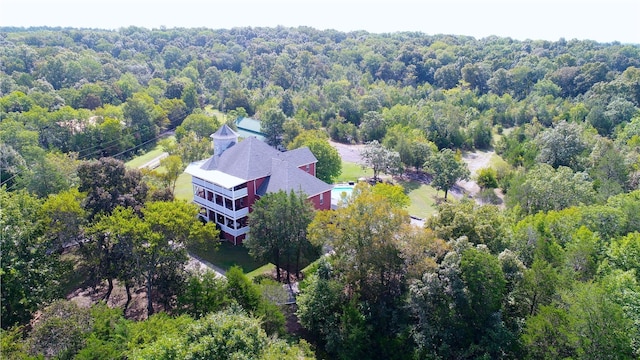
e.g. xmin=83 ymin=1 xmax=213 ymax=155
xmin=288 ymin=130 xmax=342 ymax=184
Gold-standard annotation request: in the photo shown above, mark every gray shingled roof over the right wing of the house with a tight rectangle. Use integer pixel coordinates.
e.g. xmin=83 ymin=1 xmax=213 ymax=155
xmin=257 ymin=159 xmax=331 ymax=196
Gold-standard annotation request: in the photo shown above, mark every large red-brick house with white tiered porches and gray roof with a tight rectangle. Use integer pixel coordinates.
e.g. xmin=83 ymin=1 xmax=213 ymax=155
xmin=185 ymin=124 xmax=331 ymax=245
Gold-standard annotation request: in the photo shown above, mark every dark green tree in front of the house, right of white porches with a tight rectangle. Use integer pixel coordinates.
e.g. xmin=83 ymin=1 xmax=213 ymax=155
xmin=244 ymin=190 xmax=317 ymax=282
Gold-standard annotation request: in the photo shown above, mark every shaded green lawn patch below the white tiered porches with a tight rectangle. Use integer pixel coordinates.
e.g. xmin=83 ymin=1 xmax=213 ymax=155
xmin=189 ymin=241 xmax=266 ymax=274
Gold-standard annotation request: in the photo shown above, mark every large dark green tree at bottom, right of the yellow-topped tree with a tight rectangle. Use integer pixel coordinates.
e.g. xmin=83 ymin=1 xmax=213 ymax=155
xmin=409 ymin=238 xmax=516 ymax=358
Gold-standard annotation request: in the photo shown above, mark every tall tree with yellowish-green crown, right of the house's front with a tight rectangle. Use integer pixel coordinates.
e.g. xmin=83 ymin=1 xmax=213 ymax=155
xmin=309 ymin=184 xmax=409 ymax=320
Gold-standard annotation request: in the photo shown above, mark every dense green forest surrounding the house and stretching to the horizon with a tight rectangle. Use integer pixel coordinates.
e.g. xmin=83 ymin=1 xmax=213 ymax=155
xmin=0 ymin=27 xmax=640 ymax=359
